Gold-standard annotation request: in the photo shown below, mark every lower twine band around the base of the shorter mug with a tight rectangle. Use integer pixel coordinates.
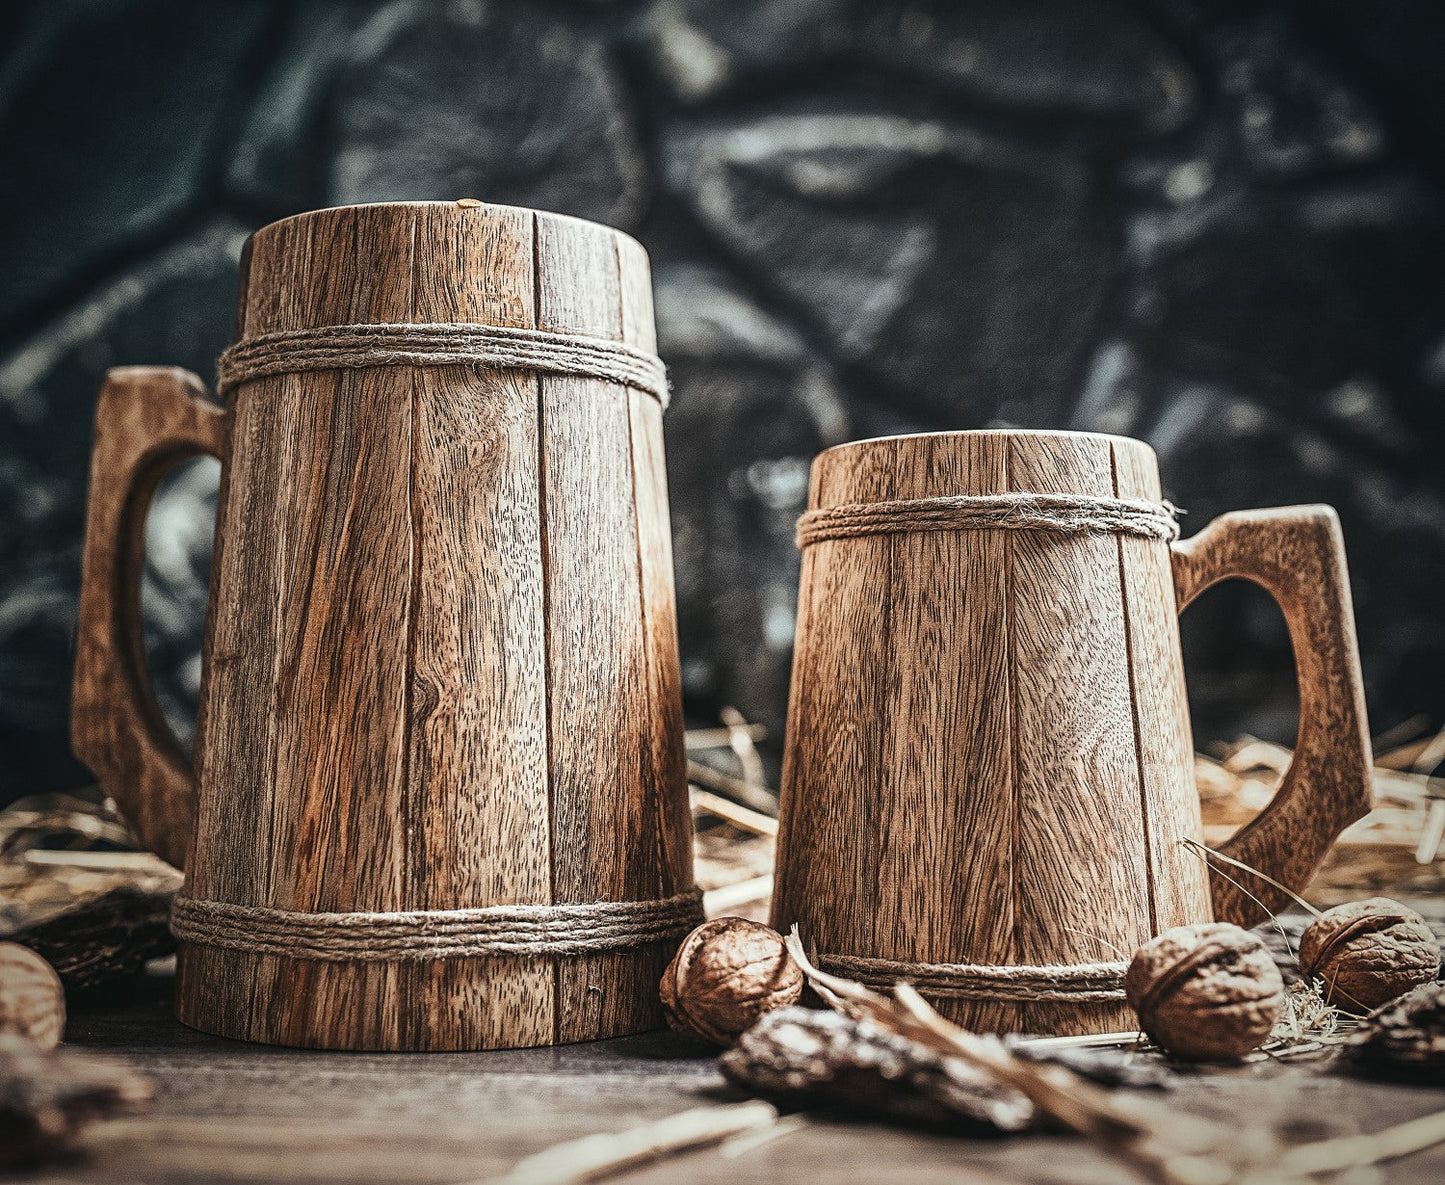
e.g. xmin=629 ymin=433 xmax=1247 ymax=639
xmin=818 ymin=955 xmax=1129 ymax=1004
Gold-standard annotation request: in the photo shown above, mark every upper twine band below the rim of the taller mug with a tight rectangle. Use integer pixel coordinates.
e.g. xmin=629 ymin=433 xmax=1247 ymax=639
xmin=215 ymin=324 xmax=668 ymax=408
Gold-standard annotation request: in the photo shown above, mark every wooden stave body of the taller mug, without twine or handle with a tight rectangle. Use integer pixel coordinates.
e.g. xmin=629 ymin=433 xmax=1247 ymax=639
xmin=71 ymin=202 xmax=692 ymax=1049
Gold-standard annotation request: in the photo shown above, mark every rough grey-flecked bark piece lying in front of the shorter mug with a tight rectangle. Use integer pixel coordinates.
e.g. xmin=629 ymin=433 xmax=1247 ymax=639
xmin=718 ymin=1007 xmax=1036 ymax=1134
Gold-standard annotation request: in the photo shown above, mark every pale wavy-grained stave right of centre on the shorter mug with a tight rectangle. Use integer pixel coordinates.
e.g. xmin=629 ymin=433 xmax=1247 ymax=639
xmin=990 ymin=434 xmax=1152 ymax=1032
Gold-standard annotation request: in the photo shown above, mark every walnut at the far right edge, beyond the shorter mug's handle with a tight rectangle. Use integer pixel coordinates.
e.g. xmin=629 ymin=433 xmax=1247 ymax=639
xmin=1299 ymin=897 xmax=1441 ymax=1012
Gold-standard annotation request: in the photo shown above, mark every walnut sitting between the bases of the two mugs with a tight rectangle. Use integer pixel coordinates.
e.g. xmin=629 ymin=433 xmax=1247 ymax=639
xmin=660 ymin=918 xmax=803 ymax=1045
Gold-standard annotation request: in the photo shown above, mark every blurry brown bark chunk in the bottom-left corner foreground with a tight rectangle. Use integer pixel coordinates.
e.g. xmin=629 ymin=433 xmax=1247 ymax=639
xmin=0 ymin=1036 xmax=155 ymax=1168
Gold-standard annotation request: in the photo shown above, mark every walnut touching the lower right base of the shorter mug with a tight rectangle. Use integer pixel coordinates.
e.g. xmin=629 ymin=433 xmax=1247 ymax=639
xmin=1124 ymin=922 xmax=1285 ymax=1061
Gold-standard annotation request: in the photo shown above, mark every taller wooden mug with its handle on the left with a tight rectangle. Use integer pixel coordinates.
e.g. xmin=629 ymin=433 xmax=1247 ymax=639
xmin=72 ymin=201 xmax=701 ymax=1049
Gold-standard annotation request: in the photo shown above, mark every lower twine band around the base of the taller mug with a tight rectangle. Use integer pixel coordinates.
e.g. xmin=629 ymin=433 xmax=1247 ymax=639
xmin=171 ymin=889 xmax=702 ymax=962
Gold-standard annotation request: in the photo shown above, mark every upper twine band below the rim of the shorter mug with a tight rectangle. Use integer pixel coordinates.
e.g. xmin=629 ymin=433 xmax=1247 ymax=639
xmin=796 ymin=494 xmax=1179 ymax=551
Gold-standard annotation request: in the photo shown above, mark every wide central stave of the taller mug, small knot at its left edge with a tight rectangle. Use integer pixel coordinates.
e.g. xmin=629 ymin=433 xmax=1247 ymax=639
xmin=407 ymin=210 xmax=555 ymax=1045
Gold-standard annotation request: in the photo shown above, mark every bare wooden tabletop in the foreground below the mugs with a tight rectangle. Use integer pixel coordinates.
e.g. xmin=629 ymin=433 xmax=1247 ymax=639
xmin=22 ymin=978 xmax=1445 ymax=1185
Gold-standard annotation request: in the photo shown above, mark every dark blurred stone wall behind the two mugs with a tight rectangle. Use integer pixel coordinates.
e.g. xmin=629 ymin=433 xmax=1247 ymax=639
xmin=0 ymin=0 xmax=1445 ymax=799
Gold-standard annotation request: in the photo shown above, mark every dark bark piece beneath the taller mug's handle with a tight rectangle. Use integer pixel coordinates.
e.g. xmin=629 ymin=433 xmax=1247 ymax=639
xmin=0 ymin=884 xmax=175 ymax=993
